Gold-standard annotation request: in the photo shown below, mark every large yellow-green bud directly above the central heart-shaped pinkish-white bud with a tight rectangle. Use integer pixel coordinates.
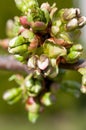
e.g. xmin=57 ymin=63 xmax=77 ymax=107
xmin=43 ymin=41 xmax=67 ymax=58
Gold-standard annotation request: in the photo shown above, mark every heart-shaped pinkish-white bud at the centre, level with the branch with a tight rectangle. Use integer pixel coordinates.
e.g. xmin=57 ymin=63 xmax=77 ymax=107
xmin=37 ymin=55 xmax=49 ymax=70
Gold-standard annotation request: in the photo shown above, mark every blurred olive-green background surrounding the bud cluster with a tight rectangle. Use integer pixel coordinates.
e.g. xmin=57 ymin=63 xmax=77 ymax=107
xmin=0 ymin=0 xmax=86 ymax=130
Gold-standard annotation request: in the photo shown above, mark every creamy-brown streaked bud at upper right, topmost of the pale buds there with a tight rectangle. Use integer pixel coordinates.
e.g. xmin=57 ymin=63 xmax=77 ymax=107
xmin=63 ymin=8 xmax=80 ymax=20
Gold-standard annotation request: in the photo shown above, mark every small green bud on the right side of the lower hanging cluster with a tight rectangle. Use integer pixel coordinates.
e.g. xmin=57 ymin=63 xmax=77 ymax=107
xmin=41 ymin=92 xmax=52 ymax=106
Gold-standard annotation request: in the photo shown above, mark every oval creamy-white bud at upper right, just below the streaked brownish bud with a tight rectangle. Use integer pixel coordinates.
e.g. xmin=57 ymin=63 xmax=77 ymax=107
xmin=66 ymin=18 xmax=78 ymax=31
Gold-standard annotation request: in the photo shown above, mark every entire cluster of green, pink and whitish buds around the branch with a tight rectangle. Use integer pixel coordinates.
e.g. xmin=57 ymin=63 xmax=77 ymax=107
xmin=3 ymin=0 xmax=86 ymax=122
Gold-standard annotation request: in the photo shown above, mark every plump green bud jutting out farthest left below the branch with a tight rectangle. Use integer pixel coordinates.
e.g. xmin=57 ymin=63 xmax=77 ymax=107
xmin=3 ymin=88 xmax=22 ymax=105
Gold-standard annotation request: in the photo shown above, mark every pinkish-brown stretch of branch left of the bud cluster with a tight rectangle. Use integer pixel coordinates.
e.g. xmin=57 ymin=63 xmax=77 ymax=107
xmin=0 ymin=56 xmax=33 ymax=74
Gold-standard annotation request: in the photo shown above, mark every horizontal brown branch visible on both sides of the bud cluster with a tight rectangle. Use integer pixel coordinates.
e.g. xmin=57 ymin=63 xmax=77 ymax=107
xmin=0 ymin=56 xmax=86 ymax=74
